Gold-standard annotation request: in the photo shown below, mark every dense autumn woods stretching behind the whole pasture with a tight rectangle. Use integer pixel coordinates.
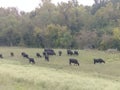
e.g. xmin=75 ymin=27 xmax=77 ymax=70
xmin=0 ymin=0 xmax=120 ymax=50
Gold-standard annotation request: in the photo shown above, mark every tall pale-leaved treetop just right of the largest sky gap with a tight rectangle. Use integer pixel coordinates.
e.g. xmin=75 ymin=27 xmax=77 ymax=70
xmin=31 ymin=0 xmax=58 ymax=29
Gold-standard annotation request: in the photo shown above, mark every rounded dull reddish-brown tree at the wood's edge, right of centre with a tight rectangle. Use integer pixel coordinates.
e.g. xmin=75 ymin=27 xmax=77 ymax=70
xmin=76 ymin=30 xmax=99 ymax=48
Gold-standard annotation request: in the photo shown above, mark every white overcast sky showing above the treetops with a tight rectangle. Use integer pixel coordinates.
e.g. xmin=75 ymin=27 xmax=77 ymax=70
xmin=0 ymin=0 xmax=94 ymax=12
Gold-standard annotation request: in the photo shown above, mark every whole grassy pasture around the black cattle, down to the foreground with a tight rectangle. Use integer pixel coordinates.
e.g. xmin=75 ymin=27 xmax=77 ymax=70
xmin=0 ymin=47 xmax=120 ymax=90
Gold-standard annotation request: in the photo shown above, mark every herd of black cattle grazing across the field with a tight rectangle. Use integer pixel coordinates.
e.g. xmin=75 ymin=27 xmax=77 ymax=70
xmin=0 ymin=49 xmax=105 ymax=66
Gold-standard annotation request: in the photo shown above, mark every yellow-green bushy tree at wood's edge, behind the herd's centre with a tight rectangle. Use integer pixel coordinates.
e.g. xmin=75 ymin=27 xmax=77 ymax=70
xmin=47 ymin=24 xmax=72 ymax=48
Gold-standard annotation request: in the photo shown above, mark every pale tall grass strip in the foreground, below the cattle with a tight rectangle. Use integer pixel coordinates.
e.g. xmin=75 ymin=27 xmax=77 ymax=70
xmin=0 ymin=64 xmax=120 ymax=90
